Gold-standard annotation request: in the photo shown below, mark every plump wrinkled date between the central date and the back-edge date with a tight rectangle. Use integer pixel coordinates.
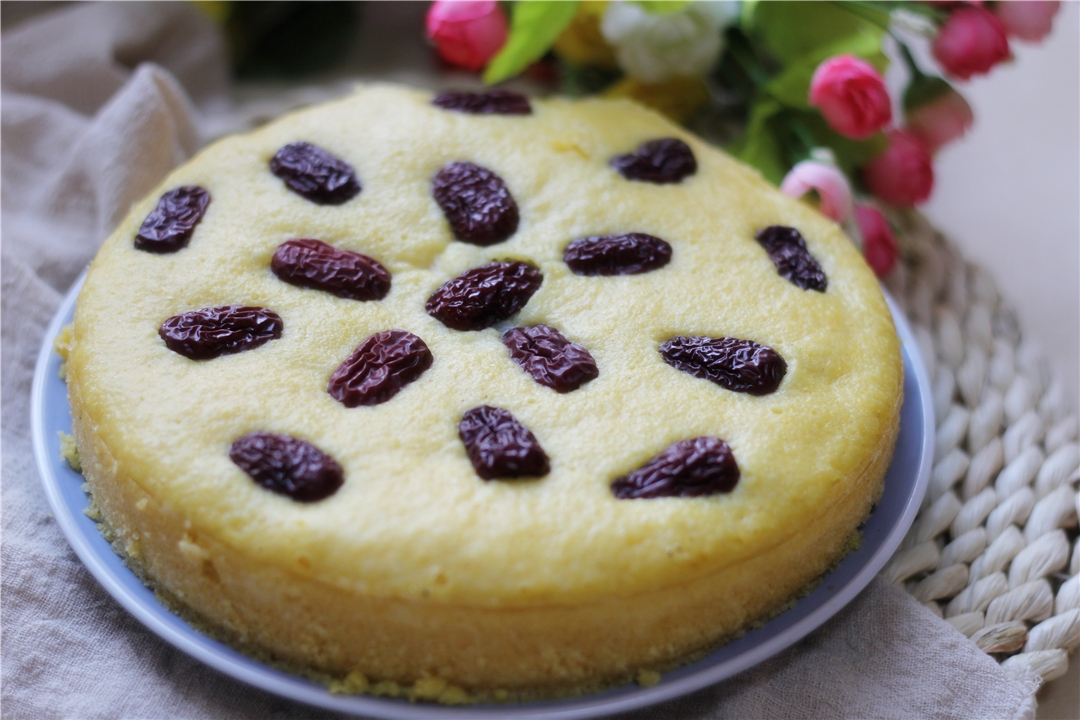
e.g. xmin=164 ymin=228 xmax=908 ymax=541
xmin=432 ymin=162 xmax=519 ymax=247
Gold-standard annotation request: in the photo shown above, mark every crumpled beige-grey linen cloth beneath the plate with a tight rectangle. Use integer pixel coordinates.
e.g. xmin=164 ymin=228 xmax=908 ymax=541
xmin=0 ymin=3 xmax=1038 ymax=720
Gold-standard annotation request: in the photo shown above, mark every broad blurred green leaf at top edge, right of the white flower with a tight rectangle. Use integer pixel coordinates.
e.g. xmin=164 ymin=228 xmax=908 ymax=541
xmin=754 ymin=1 xmax=880 ymax=65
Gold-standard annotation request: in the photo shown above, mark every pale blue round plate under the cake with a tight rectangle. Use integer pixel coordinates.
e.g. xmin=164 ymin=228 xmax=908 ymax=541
xmin=30 ymin=277 xmax=934 ymax=720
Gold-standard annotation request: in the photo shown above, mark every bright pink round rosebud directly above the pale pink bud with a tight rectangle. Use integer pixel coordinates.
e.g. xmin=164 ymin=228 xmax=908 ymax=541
xmin=810 ymin=55 xmax=892 ymax=140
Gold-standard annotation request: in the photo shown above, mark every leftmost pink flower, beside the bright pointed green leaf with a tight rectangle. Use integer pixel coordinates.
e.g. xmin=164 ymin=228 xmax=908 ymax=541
xmin=428 ymin=0 xmax=507 ymax=70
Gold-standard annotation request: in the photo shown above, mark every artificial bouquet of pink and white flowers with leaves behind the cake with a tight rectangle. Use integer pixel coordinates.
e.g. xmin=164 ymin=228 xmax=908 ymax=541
xmin=427 ymin=0 xmax=1061 ymax=276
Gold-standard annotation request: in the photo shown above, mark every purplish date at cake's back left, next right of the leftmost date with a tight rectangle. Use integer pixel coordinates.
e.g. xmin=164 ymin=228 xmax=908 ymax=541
xmin=270 ymin=142 xmax=361 ymax=205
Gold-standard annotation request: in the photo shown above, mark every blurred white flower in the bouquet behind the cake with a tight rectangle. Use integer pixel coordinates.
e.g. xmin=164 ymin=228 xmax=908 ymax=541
xmin=600 ymin=2 xmax=739 ymax=83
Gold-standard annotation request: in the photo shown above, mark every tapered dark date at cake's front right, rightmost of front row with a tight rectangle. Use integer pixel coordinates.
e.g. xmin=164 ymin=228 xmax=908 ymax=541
xmin=611 ymin=437 xmax=739 ymax=500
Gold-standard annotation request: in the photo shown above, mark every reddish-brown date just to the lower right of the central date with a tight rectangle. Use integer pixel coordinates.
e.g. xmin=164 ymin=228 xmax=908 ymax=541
xmin=502 ymin=325 xmax=599 ymax=393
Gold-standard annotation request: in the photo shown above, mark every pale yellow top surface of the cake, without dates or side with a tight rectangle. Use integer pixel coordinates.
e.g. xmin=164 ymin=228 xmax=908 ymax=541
xmin=69 ymin=85 xmax=902 ymax=606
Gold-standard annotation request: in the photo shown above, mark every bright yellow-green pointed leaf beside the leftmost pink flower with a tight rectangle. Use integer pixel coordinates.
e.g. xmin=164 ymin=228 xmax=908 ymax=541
xmin=484 ymin=0 xmax=578 ymax=85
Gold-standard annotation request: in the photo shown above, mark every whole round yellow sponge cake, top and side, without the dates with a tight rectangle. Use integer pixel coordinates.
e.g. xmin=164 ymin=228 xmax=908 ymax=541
xmin=67 ymin=85 xmax=902 ymax=694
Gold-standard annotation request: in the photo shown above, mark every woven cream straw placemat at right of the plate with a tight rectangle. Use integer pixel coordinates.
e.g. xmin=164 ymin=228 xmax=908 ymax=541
xmin=882 ymin=213 xmax=1080 ymax=683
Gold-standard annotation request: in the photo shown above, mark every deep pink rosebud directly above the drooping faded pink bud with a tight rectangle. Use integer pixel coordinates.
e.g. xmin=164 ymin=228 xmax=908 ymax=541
xmin=931 ymin=5 xmax=1010 ymax=80
